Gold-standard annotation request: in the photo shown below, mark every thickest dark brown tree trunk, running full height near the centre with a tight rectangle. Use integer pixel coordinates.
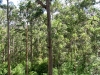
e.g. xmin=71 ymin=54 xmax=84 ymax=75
xmin=46 ymin=0 xmax=53 ymax=75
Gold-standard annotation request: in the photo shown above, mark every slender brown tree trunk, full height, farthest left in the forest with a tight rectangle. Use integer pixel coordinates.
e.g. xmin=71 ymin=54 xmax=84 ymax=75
xmin=7 ymin=0 xmax=11 ymax=75
